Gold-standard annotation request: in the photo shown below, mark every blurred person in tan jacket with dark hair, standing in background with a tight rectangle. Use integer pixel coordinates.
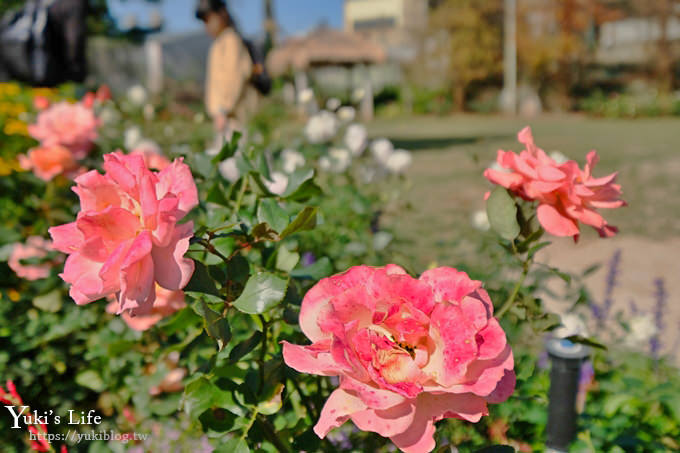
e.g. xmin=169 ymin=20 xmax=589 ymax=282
xmin=196 ymin=0 xmax=258 ymax=138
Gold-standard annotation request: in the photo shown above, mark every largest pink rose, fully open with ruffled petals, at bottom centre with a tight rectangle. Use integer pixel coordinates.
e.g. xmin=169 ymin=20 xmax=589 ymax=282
xmin=283 ymin=265 xmax=515 ymax=453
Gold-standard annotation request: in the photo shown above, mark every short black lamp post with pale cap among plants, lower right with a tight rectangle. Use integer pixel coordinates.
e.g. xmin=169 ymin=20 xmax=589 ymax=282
xmin=546 ymin=338 xmax=590 ymax=453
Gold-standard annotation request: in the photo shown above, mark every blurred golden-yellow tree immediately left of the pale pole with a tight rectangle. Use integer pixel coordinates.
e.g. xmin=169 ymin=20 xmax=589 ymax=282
xmin=431 ymin=0 xmax=502 ymax=110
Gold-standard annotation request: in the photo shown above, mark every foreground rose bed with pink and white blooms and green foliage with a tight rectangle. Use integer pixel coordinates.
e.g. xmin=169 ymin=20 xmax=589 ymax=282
xmin=0 ymin=85 xmax=680 ymax=452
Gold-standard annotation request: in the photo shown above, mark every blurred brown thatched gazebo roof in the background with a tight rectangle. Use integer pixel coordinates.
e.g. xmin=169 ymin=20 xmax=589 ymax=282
xmin=267 ymin=28 xmax=387 ymax=76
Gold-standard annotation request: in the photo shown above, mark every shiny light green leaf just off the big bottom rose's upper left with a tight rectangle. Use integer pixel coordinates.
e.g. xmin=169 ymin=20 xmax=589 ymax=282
xmin=233 ymin=272 xmax=288 ymax=315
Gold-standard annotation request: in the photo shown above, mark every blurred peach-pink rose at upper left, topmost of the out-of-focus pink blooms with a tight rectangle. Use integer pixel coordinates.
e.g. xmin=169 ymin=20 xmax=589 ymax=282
xmin=28 ymin=102 xmax=99 ymax=159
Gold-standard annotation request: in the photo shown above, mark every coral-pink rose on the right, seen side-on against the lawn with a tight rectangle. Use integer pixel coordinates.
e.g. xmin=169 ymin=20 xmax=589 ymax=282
xmin=484 ymin=127 xmax=626 ymax=240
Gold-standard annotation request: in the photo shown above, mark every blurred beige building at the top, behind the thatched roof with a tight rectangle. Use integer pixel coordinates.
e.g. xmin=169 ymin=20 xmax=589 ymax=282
xmin=344 ymin=0 xmax=429 ymax=62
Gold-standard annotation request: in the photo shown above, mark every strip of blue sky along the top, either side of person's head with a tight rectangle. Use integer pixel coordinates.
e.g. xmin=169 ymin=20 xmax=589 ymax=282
xmin=108 ymin=0 xmax=343 ymax=36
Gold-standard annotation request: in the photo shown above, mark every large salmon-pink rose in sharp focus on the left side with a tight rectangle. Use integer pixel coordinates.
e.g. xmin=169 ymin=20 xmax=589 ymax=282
xmin=50 ymin=152 xmax=198 ymax=315
